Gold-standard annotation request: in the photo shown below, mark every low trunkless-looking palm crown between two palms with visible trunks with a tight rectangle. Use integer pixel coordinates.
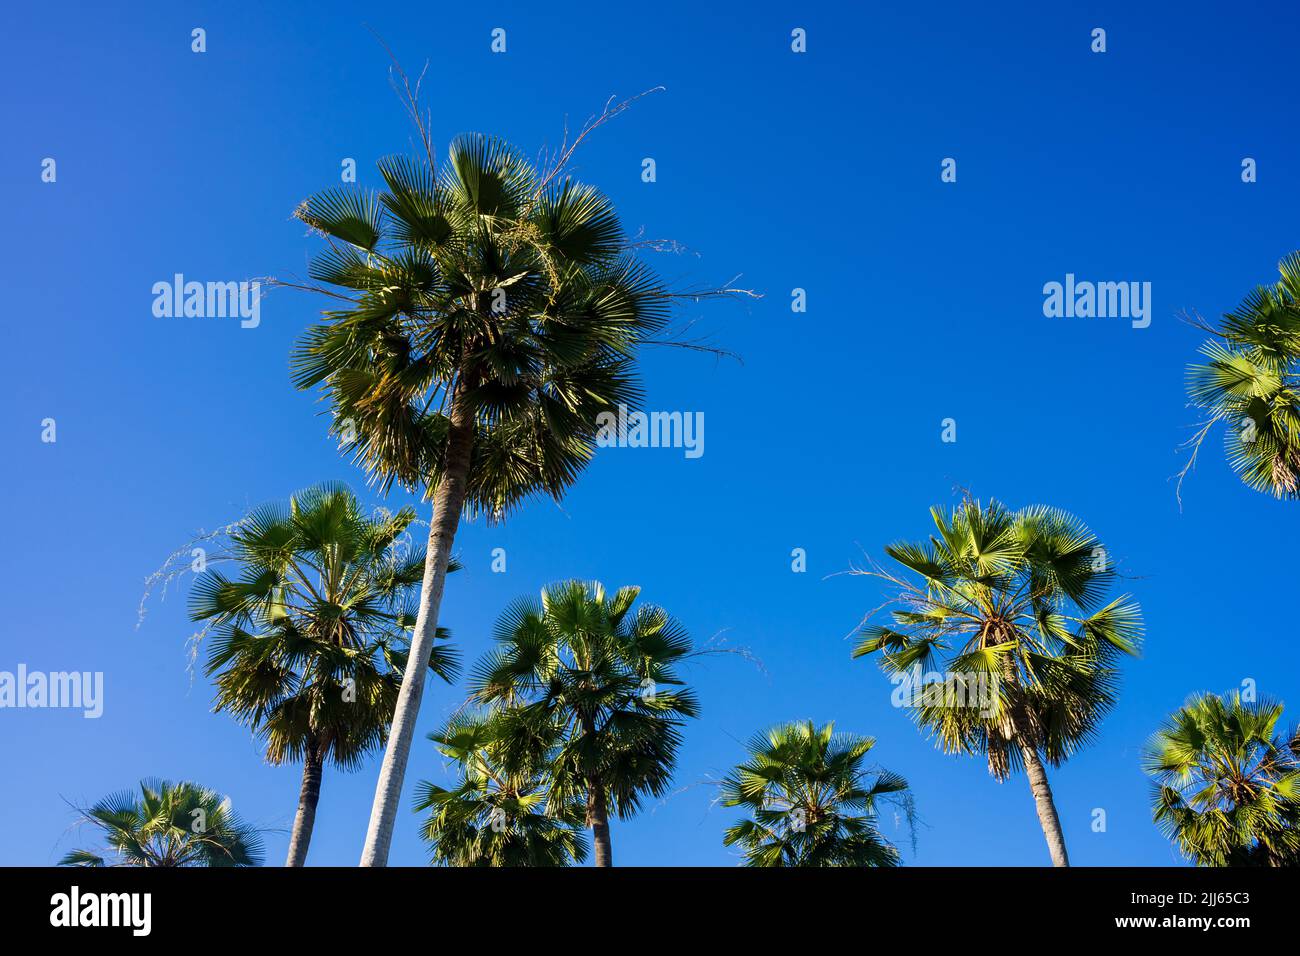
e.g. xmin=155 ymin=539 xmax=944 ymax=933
xmin=723 ymin=721 xmax=913 ymax=866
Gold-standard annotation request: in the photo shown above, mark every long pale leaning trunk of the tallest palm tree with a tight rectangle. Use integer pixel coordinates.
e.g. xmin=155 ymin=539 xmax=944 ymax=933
xmin=361 ymin=385 xmax=475 ymax=866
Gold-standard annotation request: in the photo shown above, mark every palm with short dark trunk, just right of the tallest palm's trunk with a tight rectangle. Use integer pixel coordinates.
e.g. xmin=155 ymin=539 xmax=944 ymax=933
xmin=473 ymin=581 xmax=698 ymax=866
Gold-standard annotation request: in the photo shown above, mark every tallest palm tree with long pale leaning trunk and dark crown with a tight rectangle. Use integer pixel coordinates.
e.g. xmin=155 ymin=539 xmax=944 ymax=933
xmin=293 ymin=126 xmax=673 ymax=866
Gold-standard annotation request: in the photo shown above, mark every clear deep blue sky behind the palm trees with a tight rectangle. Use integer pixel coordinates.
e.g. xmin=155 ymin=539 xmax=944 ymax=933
xmin=0 ymin=3 xmax=1300 ymax=865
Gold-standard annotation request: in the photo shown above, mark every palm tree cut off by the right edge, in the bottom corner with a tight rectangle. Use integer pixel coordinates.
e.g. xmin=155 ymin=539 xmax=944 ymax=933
xmin=1145 ymin=693 xmax=1300 ymax=866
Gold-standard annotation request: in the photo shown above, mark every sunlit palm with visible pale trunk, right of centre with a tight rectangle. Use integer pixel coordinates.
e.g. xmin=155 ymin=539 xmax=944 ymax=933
xmin=853 ymin=498 xmax=1141 ymax=866
